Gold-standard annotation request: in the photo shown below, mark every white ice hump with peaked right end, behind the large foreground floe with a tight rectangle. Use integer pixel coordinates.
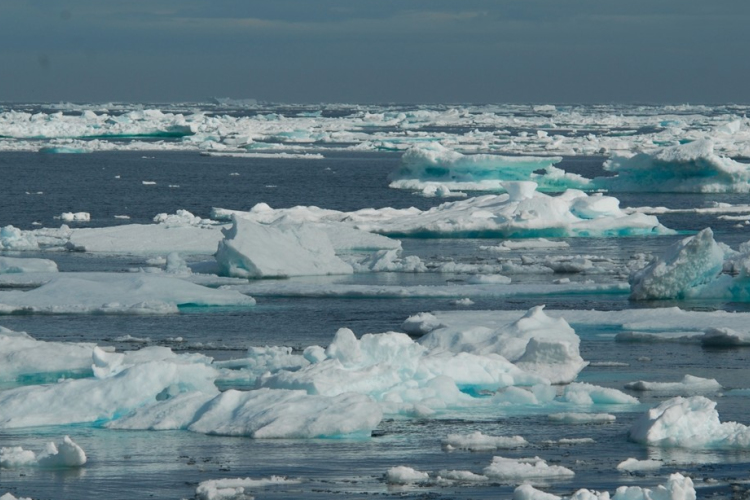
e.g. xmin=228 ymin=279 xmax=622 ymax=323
xmin=418 ymin=306 xmax=587 ymax=383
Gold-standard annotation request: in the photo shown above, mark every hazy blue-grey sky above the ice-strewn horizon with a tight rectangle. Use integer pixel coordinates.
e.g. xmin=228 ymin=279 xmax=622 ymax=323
xmin=0 ymin=0 xmax=750 ymax=103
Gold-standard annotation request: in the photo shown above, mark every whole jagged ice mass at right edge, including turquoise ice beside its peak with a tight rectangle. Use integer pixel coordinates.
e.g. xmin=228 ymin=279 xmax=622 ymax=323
xmin=630 ymin=228 xmax=750 ymax=302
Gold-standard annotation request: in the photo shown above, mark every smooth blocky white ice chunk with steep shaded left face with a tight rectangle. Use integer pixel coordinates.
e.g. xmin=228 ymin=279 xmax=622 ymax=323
xmin=216 ymin=217 xmax=353 ymax=278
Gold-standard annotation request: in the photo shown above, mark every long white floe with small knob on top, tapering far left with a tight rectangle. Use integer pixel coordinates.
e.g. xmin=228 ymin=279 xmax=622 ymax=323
xmin=213 ymin=181 xmax=672 ymax=238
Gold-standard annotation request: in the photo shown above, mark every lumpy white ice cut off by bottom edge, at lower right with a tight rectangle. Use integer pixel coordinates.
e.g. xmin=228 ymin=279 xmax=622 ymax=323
xmin=513 ymin=474 xmax=696 ymax=500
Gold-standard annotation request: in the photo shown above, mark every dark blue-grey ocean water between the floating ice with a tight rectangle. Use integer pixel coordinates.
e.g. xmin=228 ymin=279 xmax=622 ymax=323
xmin=0 ymin=151 xmax=750 ymax=500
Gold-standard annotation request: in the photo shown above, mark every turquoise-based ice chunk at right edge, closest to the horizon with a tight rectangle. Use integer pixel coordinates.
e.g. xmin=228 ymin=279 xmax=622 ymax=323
xmin=595 ymin=140 xmax=750 ymax=193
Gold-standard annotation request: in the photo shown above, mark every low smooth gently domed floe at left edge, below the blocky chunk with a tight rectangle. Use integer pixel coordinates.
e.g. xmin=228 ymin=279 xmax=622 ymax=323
xmin=0 ymin=273 xmax=255 ymax=314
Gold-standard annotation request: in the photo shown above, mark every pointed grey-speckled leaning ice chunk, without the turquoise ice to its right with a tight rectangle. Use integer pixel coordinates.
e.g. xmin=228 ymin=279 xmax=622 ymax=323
xmin=630 ymin=228 xmax=724 ymax=300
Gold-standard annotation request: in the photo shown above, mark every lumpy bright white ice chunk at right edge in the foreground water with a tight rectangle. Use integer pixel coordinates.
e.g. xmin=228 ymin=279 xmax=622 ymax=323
xmin=629 ymin=396 xmax=750 ymax=449
